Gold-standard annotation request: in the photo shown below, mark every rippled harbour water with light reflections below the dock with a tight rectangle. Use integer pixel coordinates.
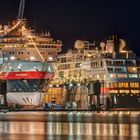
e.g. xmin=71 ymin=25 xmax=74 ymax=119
xmin=0 ymin=112 xmax=140 ymax=140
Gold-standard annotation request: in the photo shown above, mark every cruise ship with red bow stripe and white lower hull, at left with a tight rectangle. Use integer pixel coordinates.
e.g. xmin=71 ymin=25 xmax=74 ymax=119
xmin=0 ymin=19 xmax=62 ymax=106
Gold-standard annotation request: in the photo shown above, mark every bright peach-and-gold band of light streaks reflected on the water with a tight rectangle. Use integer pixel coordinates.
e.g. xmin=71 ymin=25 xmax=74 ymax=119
xmin=0 ymin=122 xmax=140 ymax=140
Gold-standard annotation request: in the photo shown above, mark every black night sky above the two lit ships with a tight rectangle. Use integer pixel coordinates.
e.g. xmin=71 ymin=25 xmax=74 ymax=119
xmin=0 ymin=0 xmax=140 ymax=55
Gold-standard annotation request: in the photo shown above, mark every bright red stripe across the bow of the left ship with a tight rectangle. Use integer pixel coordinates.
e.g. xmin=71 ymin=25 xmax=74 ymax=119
xmin=0 ymin=71 xmax=54 ymax=80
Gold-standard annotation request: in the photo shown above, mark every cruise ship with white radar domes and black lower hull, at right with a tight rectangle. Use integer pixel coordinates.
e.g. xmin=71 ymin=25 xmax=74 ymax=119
xmin=52 ymin=35 xmax=140 ymax=109
